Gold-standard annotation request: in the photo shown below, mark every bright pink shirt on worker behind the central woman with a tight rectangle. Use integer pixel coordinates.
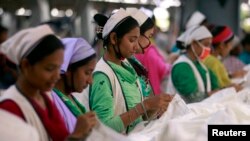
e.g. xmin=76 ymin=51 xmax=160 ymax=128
xmin=135 ymin=44 xmax=172 ymax=95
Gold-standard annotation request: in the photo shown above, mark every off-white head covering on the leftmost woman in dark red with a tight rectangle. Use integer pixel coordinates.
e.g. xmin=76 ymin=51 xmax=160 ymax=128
xmin=0 ymin=25 xmax=54 ymax=65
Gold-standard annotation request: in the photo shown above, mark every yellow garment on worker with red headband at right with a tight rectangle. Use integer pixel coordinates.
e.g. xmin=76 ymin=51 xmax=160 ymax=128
xmin=203 ymin=55 xmax=231 ymax=88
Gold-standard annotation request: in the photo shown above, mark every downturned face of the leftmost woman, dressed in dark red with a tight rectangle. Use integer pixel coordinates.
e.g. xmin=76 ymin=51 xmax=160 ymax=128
xmin=22 ymin=49 xmax=64 ymax=92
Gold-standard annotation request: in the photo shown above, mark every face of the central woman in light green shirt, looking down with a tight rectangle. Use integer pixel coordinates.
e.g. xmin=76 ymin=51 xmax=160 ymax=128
xmin=118 ymin=27 xmax=140 ymax=58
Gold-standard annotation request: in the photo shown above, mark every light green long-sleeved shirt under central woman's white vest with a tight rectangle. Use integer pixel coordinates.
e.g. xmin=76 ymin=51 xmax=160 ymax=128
xmin=90 ymin=62 xmax=142 ymax=132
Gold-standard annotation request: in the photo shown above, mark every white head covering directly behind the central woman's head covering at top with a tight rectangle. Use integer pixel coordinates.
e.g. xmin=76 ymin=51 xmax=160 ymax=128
xmin=126 ymin=7 xmax=149 ymax=26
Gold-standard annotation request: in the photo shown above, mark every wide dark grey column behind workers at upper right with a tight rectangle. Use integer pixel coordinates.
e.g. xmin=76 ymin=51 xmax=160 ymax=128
xmin=181 ymin=0 xmax=240 ymax=34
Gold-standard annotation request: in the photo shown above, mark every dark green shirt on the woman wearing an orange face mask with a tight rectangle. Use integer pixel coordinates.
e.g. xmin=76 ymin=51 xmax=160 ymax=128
xmin=171 ymin=61 xmax=218 ymax=103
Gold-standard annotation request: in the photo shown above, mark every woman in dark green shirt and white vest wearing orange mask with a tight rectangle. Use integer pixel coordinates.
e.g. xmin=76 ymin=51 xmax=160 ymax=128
xmin=169 ymin=26 xmax=218 ymax=103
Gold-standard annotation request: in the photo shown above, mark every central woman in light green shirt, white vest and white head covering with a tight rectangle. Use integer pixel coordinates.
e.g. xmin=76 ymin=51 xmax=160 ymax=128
xmin=89 ymin=8 xmax=172 ymax=133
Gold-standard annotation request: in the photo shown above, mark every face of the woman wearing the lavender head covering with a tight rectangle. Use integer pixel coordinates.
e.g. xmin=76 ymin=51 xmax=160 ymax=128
xmin=72 ymin=58 xmax=96 ymax=93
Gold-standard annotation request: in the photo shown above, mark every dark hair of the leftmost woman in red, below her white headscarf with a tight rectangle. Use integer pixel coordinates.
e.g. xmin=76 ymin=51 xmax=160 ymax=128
xmin=26 ymin=35 xmax=64 ymax=65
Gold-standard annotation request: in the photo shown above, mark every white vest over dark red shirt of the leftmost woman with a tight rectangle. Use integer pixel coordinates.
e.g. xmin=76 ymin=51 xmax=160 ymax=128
xmin=0 ymin=85 xmax=49 ymax=141
